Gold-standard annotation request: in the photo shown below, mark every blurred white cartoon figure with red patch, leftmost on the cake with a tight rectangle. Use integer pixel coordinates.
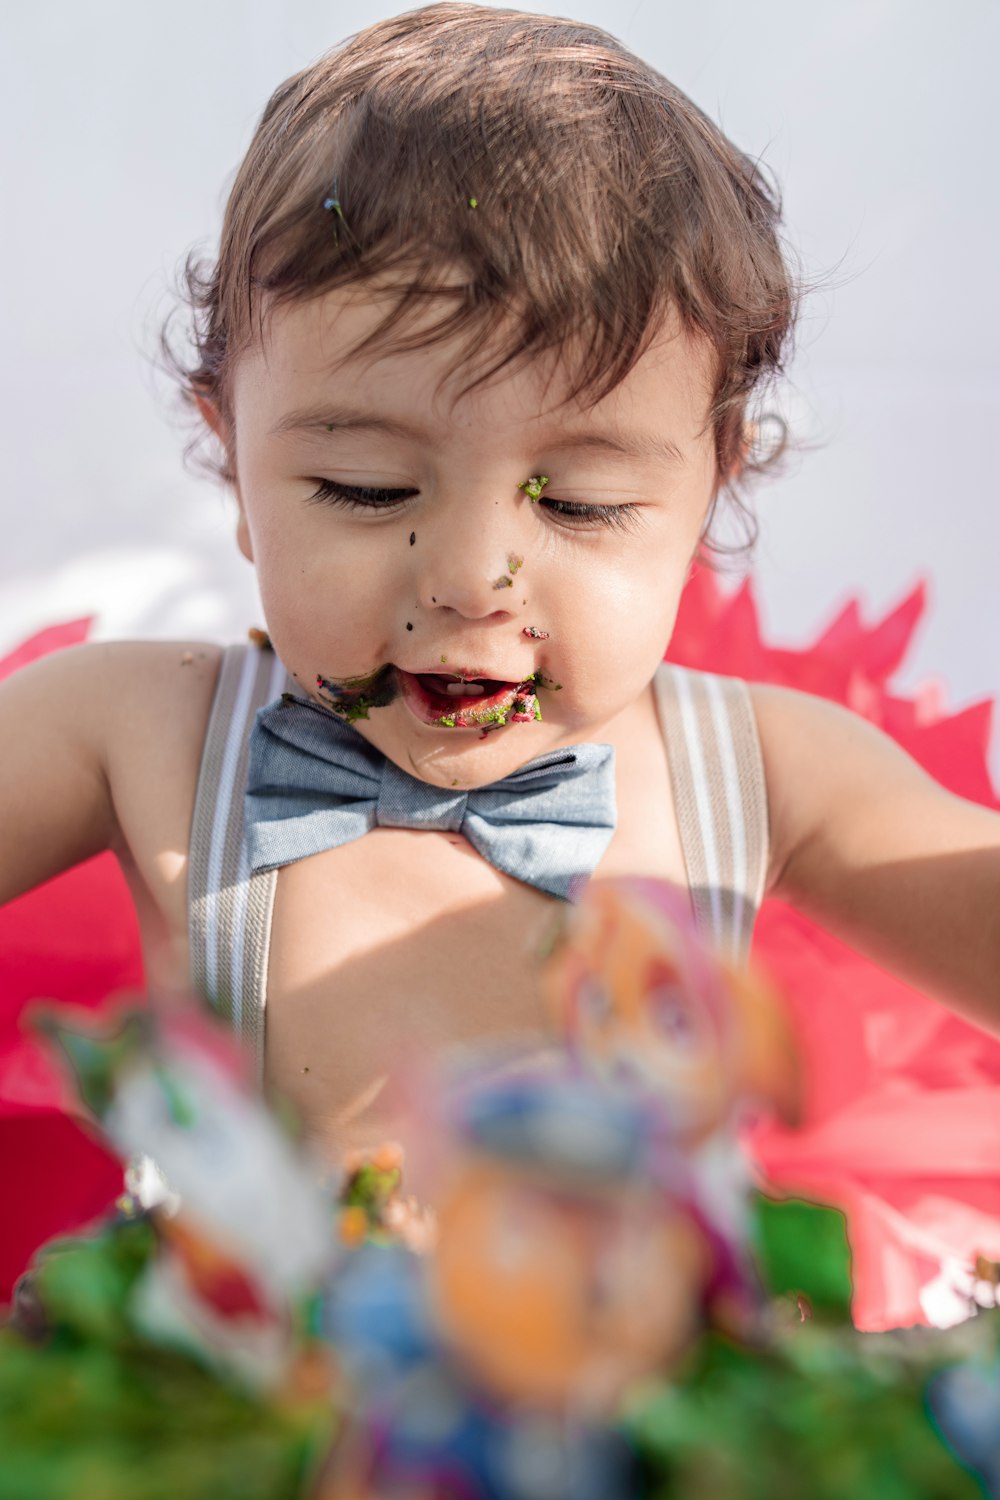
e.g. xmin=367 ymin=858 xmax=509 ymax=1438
xmin=36 ymin=1008 xmax=331 ymax=1389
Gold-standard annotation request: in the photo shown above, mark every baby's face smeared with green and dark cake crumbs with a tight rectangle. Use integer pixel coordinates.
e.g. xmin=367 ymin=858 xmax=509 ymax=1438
xmin=222 ymin=287 xmax=717 ymax=788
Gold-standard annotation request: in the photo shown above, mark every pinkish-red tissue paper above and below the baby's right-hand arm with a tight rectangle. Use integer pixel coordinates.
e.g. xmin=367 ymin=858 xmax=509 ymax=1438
xmin=669 ymin=569 xmax=1000 ymax=1331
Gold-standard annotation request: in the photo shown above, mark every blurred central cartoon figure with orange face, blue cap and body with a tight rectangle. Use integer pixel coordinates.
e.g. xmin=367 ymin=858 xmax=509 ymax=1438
xmin=322 ymin=1067 xmax=683 ymax=1500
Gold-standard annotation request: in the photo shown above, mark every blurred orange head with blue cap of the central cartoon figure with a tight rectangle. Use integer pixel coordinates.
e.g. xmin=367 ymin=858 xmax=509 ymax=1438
xmin=429 ymin=1068 xmax=715 ymax=1416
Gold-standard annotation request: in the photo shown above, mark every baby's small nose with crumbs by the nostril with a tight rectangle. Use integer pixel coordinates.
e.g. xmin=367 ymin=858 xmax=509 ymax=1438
xmin=414 ymin=492 xmax=525 ymax=624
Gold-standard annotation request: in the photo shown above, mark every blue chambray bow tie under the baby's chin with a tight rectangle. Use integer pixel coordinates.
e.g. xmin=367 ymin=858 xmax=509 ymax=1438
xmin=244 ymin=698 xmax=616 ymax=900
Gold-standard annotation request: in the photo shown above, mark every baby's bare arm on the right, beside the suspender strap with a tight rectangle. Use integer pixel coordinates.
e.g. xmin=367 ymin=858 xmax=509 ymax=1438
xmin=751 ymin=684 xmax=1000 ymax=1034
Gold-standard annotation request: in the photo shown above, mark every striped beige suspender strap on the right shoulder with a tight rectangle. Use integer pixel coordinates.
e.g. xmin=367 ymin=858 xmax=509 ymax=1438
xmin=655 ymin=663 xmax=769 ymax=966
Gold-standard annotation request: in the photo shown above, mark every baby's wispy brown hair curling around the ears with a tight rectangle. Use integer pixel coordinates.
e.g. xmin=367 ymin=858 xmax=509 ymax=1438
xmin=160 ymin=0 xmax=802 ymax=554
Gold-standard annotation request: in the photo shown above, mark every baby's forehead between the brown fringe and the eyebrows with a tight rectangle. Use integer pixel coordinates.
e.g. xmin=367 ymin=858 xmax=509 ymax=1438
xmin=232 ymin=282 xmax=717 ymax=432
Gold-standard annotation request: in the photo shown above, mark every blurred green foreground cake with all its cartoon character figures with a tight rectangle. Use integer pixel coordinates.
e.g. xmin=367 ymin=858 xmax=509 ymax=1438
xmin=0 ymin=882 xmax=1000 ymax=1500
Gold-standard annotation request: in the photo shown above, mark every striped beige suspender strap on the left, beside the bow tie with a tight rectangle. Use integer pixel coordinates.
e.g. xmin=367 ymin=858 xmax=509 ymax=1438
xmin=187 ymin=645 xmax=286 ymax=1079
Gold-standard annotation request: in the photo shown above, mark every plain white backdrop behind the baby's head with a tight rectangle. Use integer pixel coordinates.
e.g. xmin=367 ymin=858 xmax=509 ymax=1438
xmin=0 ymin=0 xmax=1000 ymax=776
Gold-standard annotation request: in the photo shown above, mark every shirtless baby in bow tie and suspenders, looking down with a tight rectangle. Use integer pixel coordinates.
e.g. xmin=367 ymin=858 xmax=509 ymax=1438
xmin=0 ymin=3 xmax=1000 ymax=1151
